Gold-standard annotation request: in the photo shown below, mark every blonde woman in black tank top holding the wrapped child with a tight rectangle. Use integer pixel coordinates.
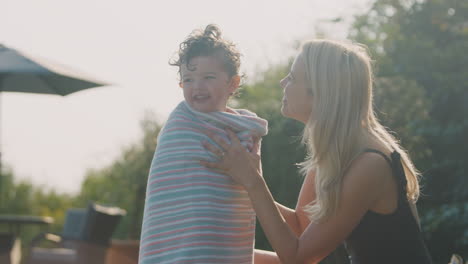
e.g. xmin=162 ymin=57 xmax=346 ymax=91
xmin=201 ymin=40 xmax=431 ymax=264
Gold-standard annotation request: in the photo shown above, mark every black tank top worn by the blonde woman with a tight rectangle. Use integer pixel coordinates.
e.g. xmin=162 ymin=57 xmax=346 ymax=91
xmin=345 ymin=149 xmax=432 ymax=264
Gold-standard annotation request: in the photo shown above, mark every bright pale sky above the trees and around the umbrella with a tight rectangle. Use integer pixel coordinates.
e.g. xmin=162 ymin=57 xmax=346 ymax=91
xmin=0 ymin=0 xmax=370 ymax=193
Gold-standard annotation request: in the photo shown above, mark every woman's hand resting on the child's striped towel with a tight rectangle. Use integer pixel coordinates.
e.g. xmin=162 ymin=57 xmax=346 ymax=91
xmin=200 ymin=130 xmax=262 ymax=190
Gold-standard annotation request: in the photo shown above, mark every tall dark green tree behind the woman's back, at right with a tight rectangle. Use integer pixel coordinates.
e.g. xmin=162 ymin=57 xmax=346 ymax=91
xmin=350 ymin=0 xmax=468 ymax=263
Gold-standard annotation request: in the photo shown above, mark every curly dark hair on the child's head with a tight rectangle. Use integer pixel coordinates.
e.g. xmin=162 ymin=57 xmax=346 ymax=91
xmin=169 ymin=24 xmax=241 ymax=77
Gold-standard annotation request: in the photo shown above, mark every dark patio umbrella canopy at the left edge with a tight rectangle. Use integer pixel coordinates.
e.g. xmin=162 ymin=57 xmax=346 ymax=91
xmin=0 ymin=44 xmax=107 ymax=200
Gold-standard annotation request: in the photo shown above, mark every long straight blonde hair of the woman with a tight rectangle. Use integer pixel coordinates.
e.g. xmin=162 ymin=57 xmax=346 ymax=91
xmin=300 ymin=40 xmax=419 ymax=221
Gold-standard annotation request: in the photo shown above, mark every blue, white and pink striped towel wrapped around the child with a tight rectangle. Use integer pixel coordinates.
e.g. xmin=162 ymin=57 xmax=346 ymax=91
xmin=139 ymin=101 xmax=267 ymax=264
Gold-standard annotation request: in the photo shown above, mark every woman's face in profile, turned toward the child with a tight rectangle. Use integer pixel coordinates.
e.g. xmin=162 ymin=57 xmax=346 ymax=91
xmin=280 ymin=55 xmax=312 ymax=123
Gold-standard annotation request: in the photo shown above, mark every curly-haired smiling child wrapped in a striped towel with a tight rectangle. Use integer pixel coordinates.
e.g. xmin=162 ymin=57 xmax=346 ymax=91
xmin=139 ymin=25 xmax=267 ymax=264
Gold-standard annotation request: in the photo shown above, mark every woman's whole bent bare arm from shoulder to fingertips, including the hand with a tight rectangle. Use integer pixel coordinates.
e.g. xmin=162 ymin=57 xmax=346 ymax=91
xmin=202 ymin=132 xmax=391 ymax=264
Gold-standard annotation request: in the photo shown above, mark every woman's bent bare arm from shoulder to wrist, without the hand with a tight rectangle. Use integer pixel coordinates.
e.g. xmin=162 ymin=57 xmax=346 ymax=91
xmin=248 ymin=155 xmax=391 ymax=263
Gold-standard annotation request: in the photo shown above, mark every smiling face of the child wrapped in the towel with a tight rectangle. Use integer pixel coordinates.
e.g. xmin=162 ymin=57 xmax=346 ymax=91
xmin=180 ymin=56 xmax=240 ymax=112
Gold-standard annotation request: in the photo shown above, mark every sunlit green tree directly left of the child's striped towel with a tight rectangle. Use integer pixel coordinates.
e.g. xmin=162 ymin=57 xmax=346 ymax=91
xmin=75 ymin=115 xmax=161 ymax=239
